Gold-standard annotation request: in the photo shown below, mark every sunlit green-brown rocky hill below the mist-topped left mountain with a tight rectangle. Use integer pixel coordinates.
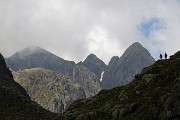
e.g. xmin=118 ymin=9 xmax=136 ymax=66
xmin=13 ymin=68 xmax=86 ymax=114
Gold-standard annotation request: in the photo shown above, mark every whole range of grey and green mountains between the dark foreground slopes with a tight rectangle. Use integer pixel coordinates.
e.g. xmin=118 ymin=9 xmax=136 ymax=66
xmin=6 ymin=43 xmax=155 ymax=114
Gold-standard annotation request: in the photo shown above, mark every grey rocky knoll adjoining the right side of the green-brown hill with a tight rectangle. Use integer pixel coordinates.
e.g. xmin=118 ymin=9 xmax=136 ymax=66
xmin=73 ymin=65 xmax=102 ymax=98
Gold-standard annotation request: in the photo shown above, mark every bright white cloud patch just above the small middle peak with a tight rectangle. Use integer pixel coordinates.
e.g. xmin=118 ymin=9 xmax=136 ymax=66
xmin=86 ymin=26 xmax=122 ymax=64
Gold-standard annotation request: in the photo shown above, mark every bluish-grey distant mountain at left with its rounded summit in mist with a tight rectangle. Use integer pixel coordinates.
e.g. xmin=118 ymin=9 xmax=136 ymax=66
xmin=6 ymin=46 xmax=75 ymax=76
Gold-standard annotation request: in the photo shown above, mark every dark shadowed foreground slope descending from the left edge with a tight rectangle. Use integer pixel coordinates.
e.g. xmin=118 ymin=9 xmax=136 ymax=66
xmin=0 ymin=54 xmax=56 ymax=120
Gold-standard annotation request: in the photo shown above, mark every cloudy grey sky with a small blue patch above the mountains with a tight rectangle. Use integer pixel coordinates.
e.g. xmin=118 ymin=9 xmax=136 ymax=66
xmin=0 ymin=0 xmax=180 ymax=63
